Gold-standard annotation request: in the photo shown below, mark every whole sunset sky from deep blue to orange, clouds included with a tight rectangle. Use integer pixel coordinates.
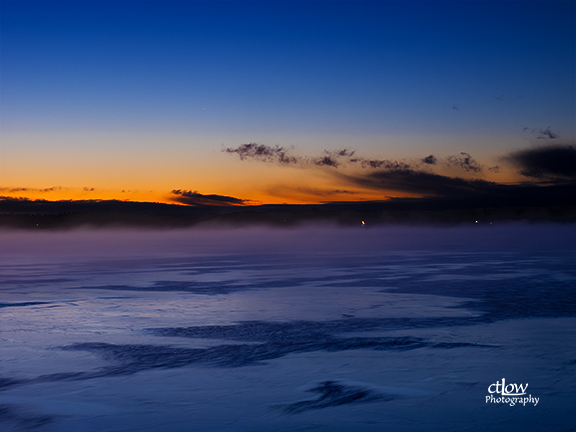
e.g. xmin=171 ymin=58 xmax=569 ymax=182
xmin=0 ymin=0 xmax=576 ymax=208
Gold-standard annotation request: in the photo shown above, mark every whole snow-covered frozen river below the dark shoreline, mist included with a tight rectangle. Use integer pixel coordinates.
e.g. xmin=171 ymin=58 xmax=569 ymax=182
xmin=0 ymin=226 xmax=576 ymax=432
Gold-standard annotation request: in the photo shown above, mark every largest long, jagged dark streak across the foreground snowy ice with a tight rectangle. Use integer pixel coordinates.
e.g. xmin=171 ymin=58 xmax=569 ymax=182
xmin=0 ymin=319 xmax=486 ymax=389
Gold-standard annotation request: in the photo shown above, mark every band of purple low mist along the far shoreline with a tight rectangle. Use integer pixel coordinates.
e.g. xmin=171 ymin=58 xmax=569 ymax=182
xmin=0 ymin=223 xmax=576 ymax=260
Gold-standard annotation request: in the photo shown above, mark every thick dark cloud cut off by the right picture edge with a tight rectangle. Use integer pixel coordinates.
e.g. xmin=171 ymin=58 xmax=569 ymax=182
xmin=503 ymin=145 xmax=576 ymax=179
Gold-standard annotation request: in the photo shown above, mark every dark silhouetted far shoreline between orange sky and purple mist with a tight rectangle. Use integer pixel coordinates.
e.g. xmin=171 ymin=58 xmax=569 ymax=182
xmin=0 ymin=202 xmax=576 ymax=231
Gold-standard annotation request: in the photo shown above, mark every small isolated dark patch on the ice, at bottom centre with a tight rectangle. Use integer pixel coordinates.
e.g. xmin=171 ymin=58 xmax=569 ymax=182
xmin=276 ymin=381 xmax=394 ymax=414
